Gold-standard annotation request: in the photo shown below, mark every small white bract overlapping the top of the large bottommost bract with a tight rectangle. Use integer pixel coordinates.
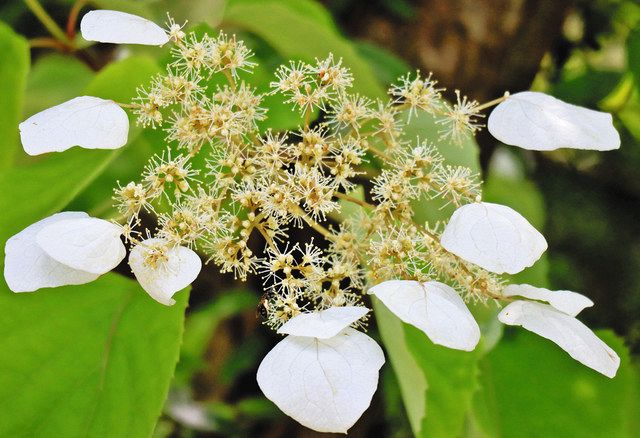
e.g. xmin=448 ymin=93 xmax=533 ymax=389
xmin=278 ymin=306 xmax=369 ymax=339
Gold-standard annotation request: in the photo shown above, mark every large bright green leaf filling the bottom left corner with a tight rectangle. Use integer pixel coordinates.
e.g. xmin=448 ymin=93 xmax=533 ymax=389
xmin=0 ymin=274 xmax=188 ymax=437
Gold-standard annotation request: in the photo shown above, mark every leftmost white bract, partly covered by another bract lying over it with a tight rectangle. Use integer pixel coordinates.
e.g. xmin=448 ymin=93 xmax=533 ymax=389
xmin=4 ymin=211 xmax=98 ymax=292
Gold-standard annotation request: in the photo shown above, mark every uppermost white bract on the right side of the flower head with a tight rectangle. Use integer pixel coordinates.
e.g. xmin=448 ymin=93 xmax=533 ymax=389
xmin=487 ymin=91 xmax=620 ymax=151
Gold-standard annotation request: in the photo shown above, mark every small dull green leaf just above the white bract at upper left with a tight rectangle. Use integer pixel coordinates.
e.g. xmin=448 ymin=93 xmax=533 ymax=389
xmin=24 ymin=54 xmax=95 ymax=117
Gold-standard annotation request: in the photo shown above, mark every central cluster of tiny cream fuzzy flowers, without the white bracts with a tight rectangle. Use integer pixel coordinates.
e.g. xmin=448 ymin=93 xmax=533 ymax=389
xmin=121 ymin=28 xmax=500 ymax=328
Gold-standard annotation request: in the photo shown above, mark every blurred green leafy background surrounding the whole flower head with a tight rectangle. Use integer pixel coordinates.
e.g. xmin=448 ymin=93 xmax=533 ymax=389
xmin=0 ymin=0 xmax=640 ymax=438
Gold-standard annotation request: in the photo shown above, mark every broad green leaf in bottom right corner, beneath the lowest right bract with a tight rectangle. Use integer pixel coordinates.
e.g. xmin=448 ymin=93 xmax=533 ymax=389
xmin=474 ymin=329 xmax=638 ymax=438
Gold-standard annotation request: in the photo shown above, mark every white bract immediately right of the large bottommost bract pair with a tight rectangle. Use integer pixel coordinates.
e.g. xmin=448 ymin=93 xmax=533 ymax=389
xmin=369 ymin=280 xmax=480 ymax=351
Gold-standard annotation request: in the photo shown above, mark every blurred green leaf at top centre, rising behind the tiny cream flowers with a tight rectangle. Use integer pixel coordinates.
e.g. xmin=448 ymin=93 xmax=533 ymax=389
xmin=224 ymin=0 xmax=384 ymax=97
